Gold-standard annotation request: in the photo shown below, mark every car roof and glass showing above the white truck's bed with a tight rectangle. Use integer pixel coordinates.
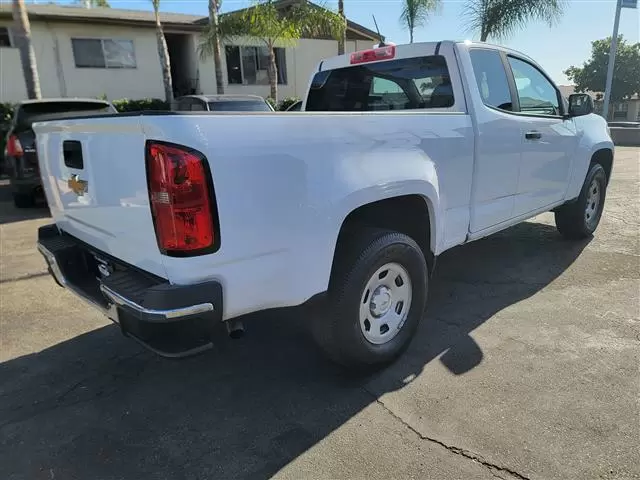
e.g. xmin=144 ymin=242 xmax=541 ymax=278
xmin=171 ymin=95 xmax=273 ymax=112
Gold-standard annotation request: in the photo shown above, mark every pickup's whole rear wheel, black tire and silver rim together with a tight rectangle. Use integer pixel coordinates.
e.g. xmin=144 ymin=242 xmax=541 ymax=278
xmin=314 ymin=230 xmax=428 ymax=369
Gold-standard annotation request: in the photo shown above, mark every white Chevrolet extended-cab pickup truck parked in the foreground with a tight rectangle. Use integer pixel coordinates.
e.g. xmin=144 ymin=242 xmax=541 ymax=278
xmin=34 ymin=41 xmax=614 ymax=368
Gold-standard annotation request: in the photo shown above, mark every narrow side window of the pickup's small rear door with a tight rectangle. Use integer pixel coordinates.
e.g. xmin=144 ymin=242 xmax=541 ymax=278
xmin=469 ymin=48 xmax=513 ymax=112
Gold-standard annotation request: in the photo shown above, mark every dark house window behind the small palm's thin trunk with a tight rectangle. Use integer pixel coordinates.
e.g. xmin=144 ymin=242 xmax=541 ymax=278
xmin=225 ymin=46 xmax=287 ymax=85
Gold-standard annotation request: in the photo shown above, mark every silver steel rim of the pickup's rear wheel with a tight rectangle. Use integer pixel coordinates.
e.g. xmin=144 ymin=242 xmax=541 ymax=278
xmin=360 ymin=263 xmax=412 ymax=345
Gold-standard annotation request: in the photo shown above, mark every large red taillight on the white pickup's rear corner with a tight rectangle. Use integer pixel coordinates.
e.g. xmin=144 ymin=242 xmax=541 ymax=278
xmin=147 ymin=141 xmax=219 ymax=256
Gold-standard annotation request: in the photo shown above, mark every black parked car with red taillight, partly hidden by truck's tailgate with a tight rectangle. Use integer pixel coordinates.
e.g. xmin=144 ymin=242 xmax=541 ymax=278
xmin=4 ymin=98 xmax=117 ymax=208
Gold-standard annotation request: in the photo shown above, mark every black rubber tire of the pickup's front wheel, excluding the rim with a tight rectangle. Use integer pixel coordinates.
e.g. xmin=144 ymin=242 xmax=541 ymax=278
xmin=555 ymin=163 xmax=607 ymax=240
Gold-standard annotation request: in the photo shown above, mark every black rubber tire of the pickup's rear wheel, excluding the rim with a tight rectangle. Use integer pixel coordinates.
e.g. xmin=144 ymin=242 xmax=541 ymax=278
xmin=314 ymin=229 xmax=428 ymax=370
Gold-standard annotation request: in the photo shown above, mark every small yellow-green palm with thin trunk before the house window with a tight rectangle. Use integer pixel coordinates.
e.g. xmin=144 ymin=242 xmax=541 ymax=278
xmin=199 ymin=0 xmax=346 ymax=102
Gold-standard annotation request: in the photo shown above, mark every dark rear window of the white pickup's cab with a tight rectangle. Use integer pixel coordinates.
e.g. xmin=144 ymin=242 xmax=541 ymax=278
xmin=305 ymin=55 xmax=455 ymax=112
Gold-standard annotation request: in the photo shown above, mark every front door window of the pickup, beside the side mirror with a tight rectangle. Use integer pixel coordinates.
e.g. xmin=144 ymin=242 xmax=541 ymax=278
xmin=508 ymin=57 xmax=560 ymax=115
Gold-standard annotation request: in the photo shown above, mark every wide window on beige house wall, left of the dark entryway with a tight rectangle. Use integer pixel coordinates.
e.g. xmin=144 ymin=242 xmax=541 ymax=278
xmin=71 ymin=38 xmax=136 ymax=68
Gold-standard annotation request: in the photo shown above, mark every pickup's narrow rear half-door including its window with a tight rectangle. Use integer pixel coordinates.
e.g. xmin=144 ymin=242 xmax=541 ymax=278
xmin=467 ymin=48 xmax=523 ymax=233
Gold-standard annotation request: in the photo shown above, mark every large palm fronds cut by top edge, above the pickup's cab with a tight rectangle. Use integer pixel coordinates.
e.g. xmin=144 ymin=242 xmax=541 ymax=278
xmin=466 ymin=0 xmax=565 ymax=42
